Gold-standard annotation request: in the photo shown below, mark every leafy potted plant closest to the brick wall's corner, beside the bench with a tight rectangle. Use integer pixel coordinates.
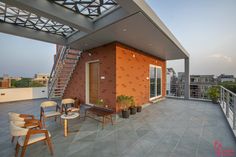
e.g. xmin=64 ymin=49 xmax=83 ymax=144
xmin=117 ymin=95 xmax=130 ymax=118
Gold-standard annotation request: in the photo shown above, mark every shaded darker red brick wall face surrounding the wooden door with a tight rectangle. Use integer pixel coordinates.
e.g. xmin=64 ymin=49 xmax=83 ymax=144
xmin=63 ymin=43 xmax=116 ymax=109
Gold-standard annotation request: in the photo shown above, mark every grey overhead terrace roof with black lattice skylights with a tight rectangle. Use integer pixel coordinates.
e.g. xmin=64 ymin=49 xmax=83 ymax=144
xmin=0 ymin=0 xmax=189 ymax=97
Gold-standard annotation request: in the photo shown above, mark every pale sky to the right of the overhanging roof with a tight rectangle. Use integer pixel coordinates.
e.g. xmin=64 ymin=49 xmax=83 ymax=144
xmin=146 ymin=0 xmax=236 ymax=75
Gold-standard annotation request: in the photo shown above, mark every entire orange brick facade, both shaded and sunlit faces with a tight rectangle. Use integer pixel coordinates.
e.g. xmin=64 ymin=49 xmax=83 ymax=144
xmin=64 ymin=43 xmax=166 ymax=112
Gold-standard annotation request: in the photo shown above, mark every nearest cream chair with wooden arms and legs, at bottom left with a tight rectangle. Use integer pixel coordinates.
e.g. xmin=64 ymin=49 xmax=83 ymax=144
xmin=10 ymin=121 xmax=53 ymax=157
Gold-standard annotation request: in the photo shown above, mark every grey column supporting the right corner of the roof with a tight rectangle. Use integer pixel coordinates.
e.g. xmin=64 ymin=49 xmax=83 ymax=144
xmin=184 ymin=58 xmax=190 ymax=99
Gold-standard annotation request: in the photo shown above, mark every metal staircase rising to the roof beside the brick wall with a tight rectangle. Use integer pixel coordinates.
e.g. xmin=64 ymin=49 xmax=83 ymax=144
xmin=48 ymin=46 xmax=81 ymax=98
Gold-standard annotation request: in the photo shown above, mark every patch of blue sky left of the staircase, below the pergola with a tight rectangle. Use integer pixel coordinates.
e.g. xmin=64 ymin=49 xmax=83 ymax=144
xmin=0 ymin=33 xmax=56 ymax=77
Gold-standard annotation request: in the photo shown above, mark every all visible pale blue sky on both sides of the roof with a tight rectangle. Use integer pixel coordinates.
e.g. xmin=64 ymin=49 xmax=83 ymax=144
xmin=0 ymin=0 xmax=236 ymax=77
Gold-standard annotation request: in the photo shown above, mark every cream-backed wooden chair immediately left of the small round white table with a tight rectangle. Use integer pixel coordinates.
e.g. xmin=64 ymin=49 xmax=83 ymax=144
xmin=40 ymin=101 xmax=61 ymax=128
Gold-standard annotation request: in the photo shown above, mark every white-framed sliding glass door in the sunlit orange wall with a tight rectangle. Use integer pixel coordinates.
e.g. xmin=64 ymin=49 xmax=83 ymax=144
xmin=149 ymin=65 xmax=162 ymax=99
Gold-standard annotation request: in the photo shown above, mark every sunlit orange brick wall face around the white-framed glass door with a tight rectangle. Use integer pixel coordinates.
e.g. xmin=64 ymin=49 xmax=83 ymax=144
xmin=116 ymin=44 xmax=166 ymax=111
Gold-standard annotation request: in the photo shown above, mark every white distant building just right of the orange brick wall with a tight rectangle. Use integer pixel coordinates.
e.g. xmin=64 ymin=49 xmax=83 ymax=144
xmin=166 ymin=68 xmax=177 ymax=95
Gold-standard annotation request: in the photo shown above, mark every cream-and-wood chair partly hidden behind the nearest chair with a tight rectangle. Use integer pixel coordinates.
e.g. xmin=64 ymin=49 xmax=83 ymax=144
xmin=8 ymin=112 xmax=42 ymax=143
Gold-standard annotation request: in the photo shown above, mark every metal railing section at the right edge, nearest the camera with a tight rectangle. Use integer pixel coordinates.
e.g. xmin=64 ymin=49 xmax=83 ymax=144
xmin=220 ymin=86 xmax=236 ymax=130
